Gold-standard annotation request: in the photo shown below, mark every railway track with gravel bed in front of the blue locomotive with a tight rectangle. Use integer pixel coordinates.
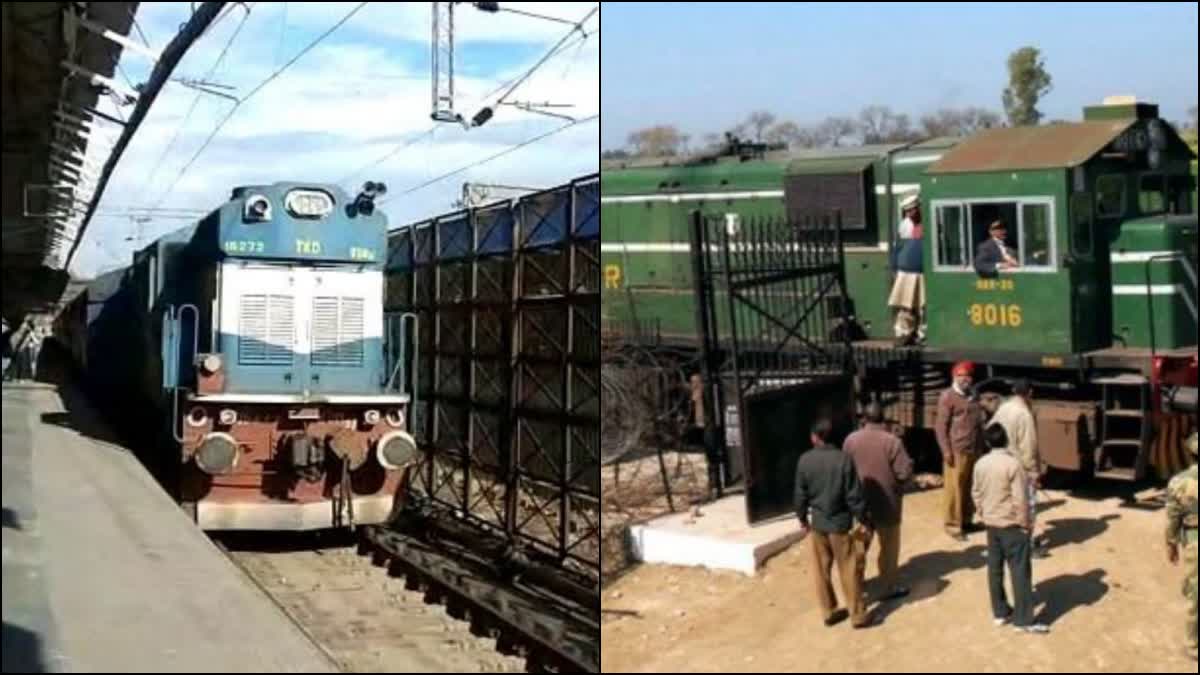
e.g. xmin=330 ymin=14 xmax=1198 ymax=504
xmin=214 ymin=511 xmax=600 ymax=673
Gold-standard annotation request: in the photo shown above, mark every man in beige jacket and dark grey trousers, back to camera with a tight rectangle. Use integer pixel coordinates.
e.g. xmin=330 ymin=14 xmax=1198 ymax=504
xmin=971 ymin=424 xmax=1050 ymax=634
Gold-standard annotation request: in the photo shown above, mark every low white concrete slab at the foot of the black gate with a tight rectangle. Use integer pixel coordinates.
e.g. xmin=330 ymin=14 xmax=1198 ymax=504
xmin=630 ymin=495 xmax=800 ymax=574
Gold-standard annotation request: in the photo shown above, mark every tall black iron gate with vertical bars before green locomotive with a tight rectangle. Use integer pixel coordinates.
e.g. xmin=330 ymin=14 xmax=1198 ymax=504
xmin=691 ymin=211 xmax=853 ymax=521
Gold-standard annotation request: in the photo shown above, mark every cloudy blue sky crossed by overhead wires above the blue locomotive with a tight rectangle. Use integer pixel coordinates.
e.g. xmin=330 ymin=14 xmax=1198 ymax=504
xmin=71 ymin=2 xmax=600 ymax=276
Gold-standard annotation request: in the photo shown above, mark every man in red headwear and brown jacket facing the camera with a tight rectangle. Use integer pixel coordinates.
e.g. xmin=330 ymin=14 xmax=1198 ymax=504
xmin=935 ymin=362 xmax=983 ymax=542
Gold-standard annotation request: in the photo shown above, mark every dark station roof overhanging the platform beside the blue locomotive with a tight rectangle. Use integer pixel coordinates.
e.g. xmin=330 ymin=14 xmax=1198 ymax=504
xmin=0 ymin=2 xmax=139 ymax=322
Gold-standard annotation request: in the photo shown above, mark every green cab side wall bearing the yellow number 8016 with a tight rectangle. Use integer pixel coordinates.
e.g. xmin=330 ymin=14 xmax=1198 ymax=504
xmin=922 ymin=171 xmax=1081 ymax=353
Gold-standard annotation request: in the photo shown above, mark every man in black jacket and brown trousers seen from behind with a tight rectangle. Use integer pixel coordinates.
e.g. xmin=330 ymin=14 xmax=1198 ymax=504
xmin=796 ymin=418 xmax=871 ymax=628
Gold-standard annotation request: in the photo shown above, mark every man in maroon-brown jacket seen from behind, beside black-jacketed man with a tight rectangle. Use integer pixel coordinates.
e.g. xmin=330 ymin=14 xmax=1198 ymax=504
xmin=842 ymin=402 xmax=912 ymax=599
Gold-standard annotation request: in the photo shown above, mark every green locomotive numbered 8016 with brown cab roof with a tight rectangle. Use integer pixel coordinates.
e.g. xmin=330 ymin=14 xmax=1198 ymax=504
xmin=601 ymin=100 xmax=1196 ymax=478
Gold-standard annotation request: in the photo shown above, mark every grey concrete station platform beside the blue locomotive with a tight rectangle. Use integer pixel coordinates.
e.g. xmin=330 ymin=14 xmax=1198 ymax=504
xmin=2 ymin=382 xmax=336 ymax=673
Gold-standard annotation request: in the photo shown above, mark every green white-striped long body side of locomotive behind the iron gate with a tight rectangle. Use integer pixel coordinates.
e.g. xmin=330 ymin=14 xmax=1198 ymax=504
xmin=601 ymin=148 xmax=956 ymax=340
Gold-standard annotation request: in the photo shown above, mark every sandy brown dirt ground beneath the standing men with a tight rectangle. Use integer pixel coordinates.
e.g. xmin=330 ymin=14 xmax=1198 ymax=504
xmin=601 ymin=486 xmax=1196 ymax=673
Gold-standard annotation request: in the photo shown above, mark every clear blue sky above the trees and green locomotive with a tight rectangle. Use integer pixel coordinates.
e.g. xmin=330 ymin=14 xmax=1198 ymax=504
xmin=601 ymin=2 xmax=1198 ymax=148
